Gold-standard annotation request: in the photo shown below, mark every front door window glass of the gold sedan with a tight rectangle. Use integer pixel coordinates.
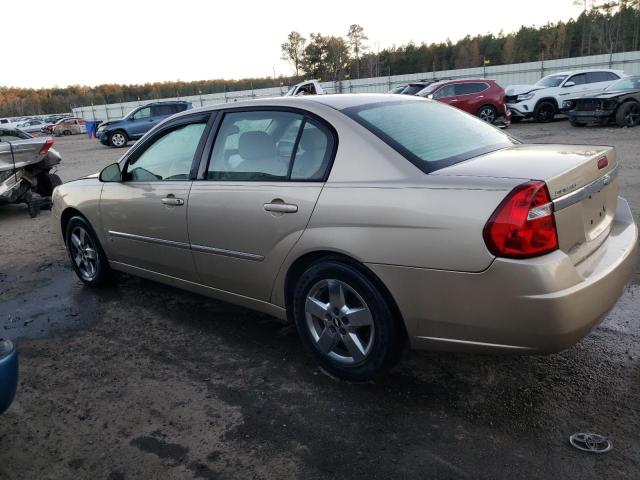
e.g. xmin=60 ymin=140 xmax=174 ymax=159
xmin=126 ymin=123 xmax=206 ymax=182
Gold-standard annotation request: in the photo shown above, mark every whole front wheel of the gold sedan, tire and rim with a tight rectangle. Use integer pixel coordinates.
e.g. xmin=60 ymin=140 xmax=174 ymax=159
xmin=65 ymin=216 xmax=114 ymax=287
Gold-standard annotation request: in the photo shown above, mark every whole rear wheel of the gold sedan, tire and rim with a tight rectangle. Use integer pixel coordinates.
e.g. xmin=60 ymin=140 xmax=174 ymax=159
xmin=293 ymin=258 xmax=406 ymax=382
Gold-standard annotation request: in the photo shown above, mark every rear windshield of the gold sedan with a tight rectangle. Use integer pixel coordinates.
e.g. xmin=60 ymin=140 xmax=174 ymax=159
xmin=342 ymin=100 xmax=517 ymax=173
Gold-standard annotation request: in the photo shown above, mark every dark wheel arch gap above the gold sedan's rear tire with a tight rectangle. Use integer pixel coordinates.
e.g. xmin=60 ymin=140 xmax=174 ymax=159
xmin=284 ymin=250 xmax=409 ymax=341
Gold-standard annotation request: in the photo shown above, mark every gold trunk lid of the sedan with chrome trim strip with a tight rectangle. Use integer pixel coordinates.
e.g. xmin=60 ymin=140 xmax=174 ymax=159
xmin=431 ymin=145 xmax=618 ymax=264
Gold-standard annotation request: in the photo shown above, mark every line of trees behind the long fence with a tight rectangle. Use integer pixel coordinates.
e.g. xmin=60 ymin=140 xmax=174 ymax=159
xmin=0 ymin=0 xmax=640 ymax=116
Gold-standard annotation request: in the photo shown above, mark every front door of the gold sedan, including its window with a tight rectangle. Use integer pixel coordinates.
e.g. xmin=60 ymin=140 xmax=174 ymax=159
xmin=100 ymin=113 xmax=209 ymax=281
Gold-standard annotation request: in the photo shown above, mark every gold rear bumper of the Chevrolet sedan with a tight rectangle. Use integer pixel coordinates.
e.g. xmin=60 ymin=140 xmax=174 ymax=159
xmin=368 ymin=198 xmax=638 ymax=353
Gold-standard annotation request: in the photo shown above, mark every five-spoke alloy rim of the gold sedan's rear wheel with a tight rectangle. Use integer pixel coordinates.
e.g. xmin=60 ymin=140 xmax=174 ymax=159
xmin=304 ymin=279 xmax=375 ymax=365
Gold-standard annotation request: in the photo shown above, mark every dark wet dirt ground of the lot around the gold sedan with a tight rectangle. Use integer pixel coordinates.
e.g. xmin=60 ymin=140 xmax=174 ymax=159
xmin=0 ymin=121 xmax=640 ymax=480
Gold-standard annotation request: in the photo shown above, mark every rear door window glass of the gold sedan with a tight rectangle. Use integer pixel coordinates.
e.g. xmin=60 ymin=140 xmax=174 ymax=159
xmin=207 ymin=111 xmax=333 ymax=181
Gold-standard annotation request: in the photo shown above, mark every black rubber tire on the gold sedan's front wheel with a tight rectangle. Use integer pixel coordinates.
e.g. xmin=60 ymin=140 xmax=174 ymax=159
xmin=64 ymin=216 xmax=115 ymax=287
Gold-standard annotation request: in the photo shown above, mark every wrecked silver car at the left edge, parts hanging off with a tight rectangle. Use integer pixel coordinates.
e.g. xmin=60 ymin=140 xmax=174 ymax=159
xmin=0 ymin=127 xmax=62 ymax=217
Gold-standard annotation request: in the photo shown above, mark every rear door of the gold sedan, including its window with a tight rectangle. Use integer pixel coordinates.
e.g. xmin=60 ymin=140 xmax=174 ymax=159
xmin=188 ymin=109 xmax=337 ymax=301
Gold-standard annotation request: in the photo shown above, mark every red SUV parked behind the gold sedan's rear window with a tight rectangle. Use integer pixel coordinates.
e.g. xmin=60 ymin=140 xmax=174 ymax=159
xmin=416 ymin=78 xmax=511 ymax=126
